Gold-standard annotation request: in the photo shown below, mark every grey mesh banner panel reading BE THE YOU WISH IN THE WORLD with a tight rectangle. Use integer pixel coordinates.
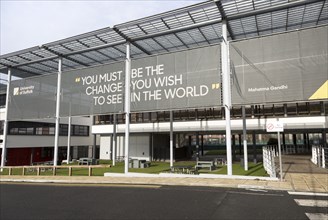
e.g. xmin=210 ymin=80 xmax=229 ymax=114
xmin=131 ymin=46 xmax=221 ymax=112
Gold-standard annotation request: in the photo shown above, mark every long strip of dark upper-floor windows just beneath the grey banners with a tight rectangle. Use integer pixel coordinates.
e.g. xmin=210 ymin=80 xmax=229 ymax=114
xmin=95 ymin=101 xmax=328 ymax=125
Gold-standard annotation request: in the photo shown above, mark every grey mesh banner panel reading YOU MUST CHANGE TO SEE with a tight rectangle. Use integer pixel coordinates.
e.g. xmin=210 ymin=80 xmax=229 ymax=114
xmin=60 ymin=59 xmax=125 ymax=116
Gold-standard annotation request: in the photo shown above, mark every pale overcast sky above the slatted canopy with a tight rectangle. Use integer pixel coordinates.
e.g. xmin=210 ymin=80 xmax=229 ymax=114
xmin=0 ymin=0 xmax=202 ymax=54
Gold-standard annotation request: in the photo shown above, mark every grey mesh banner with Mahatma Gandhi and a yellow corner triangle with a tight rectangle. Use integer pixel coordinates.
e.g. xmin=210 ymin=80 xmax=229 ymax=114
xmin=230 ymin=27 xmax=328 ymax=104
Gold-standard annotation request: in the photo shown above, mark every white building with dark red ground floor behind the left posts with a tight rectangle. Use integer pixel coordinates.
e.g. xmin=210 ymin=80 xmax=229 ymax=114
xmin=0 ymin=89 xmax=99 ymax=166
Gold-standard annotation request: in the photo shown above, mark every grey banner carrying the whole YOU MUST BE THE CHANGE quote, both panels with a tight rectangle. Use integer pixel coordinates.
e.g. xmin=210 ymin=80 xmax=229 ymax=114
xmin=60 ymin=46 xmax=221 ymax=116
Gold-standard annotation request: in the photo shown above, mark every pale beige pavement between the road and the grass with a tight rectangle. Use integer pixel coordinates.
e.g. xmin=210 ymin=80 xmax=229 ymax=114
xmin=0 ymin=156 xmax=328 ymax=193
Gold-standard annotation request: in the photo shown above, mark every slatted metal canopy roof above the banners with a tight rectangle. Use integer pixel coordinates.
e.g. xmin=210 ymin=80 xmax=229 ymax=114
xmin=0 ymin=0 xmax=328 ymax=78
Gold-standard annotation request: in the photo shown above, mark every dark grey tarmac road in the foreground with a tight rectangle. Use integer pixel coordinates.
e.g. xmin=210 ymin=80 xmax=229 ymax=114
xmin=0 ymin=183 xmax=322 ymax=220
